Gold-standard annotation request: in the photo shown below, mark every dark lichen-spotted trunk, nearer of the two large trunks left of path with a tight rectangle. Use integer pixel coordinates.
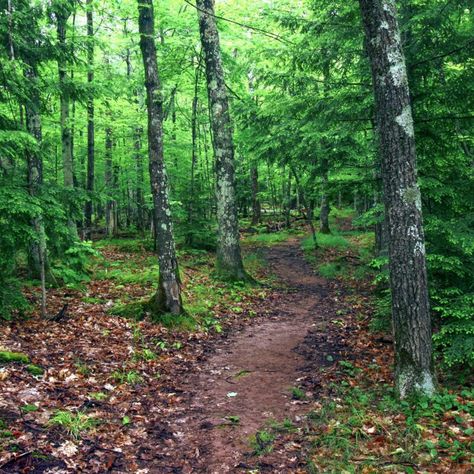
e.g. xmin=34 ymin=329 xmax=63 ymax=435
xmin=138 ymin=0 xmax=183 ymax=314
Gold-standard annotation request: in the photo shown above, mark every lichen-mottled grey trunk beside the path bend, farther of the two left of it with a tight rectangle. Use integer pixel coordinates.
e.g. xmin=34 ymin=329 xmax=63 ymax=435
xmin=196 ymin=0 xmax=248 ymax=280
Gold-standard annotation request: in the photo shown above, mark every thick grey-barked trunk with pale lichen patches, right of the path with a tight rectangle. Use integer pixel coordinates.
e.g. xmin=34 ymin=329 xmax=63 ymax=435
xmin=359 ymin=0 xmax=435 ymax=398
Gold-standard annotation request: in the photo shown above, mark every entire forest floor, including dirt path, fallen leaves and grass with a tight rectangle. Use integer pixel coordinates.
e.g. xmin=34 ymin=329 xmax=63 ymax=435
xmin=0 ymin=217 xmax=474 ymax=474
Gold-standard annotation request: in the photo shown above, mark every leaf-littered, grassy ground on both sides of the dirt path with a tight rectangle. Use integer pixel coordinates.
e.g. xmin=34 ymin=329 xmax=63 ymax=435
xmin=0 ymin=222 xmax=474 ymax=473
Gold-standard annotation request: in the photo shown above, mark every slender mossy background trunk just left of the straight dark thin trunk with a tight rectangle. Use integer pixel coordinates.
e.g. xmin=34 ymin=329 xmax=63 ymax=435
xmin=56 ymin=2 xmax=77 ymax=237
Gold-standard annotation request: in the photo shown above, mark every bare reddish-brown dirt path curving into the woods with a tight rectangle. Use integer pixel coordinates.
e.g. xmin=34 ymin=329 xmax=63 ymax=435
xmin=150 ymin=240 xmax=334 ymax=474
